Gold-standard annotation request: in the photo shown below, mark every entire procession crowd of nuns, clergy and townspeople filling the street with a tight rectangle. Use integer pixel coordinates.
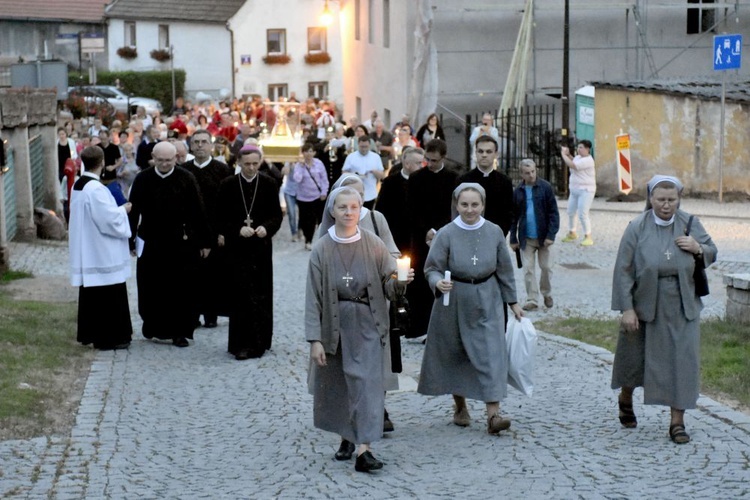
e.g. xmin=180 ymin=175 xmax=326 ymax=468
xmin=67 ymin=95 xmax=716 ymax=472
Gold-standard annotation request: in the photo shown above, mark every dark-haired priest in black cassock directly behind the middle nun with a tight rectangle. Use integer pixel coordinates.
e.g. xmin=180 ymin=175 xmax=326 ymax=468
xmin=458 ymin=135 xmax=514 ymax=236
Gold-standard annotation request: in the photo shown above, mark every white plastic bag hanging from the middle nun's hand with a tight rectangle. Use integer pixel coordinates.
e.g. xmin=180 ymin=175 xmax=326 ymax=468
xmin=505 ymin=314 xmax=537 ymax=397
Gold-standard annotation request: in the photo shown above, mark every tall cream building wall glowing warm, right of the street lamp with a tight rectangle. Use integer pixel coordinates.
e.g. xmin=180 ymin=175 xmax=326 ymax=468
xmin=340 ymin=0 xmax=415 ymax=127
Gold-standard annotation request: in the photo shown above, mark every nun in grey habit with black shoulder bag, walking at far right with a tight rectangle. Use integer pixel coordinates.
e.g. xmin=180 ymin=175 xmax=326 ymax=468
xmin=612 ymin=175 xmax=717 ymax=444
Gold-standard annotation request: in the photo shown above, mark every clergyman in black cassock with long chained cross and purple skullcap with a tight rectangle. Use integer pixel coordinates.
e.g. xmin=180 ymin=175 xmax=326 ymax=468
xmin=218 ymin=145 xmax=282 ymax=360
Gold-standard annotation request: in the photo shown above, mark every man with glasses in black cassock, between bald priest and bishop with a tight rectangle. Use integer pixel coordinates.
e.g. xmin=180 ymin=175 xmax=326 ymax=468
xmin=182 ymin=130 xmax=234 ymax=328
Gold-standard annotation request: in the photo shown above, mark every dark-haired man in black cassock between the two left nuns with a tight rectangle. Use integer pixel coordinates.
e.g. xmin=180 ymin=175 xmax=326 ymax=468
xmin=406 ymin=139 xmax=458 ymax=337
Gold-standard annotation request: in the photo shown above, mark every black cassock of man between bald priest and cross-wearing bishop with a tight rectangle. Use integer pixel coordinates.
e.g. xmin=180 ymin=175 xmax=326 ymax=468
xmin=182 ymin=160 xmax=234 ymax=323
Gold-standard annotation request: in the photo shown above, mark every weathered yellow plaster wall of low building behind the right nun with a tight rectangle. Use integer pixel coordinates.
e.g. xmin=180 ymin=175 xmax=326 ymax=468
xmin=594 ymin=89 xmax=750 ymax=196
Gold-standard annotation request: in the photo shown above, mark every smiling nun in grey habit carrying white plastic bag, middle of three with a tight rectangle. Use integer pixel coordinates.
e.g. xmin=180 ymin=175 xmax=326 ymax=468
xmin=418 ymin=183 xmax=523 ymax=434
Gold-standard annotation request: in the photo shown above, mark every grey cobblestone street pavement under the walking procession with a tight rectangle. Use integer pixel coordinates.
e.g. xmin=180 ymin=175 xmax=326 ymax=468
xmin=0 ymin=200 xmax=750 ymax=499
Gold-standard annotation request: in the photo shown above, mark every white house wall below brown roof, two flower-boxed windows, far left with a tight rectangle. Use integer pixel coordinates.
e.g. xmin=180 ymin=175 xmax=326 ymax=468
xmin=108 ymin=19 xmax=232 ymax=98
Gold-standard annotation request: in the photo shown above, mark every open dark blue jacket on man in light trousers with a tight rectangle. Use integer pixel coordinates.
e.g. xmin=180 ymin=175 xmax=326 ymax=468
xmin=510 ymin=178 xmax=560 ymax=249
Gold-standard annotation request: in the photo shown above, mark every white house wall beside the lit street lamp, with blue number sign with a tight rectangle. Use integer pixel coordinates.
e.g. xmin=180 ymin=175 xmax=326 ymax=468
xmin=228 ymin=0 xmax=344 ymax=105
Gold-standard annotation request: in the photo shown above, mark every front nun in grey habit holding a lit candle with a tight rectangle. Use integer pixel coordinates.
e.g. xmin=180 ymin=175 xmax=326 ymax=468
xmin=305 ymin=187 xmax=413 ymax=472
